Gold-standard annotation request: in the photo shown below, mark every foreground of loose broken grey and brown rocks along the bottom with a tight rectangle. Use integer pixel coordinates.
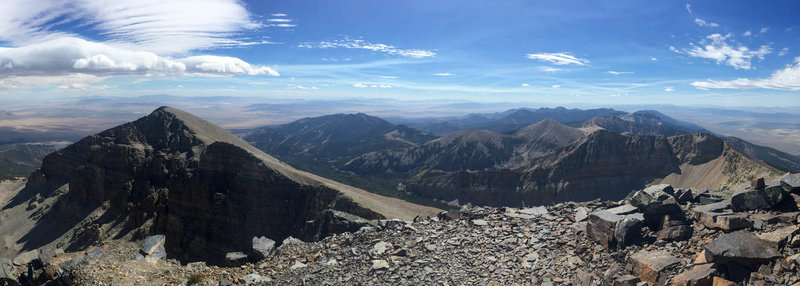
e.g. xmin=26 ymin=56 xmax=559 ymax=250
xmin=4 ymin=174 xmax=800 ymax=285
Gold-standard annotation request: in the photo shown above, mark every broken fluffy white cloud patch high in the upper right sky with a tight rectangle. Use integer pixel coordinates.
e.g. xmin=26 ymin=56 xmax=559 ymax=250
xmin=684 ymin=34 xmax=772 ymax=69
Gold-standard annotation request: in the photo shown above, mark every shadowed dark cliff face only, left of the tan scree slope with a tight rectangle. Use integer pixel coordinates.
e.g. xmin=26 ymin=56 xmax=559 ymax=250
xmin=410 ymin=131 xmax=680 ymax=206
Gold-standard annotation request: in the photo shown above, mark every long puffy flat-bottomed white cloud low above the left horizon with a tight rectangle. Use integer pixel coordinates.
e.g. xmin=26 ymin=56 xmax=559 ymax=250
xmin=0 ymin=38 xmax=279 ymax=78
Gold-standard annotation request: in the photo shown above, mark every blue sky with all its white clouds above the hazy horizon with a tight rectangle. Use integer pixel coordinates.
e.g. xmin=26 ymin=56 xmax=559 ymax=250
xmin=0 ymin=0 xmax=800 ymax=107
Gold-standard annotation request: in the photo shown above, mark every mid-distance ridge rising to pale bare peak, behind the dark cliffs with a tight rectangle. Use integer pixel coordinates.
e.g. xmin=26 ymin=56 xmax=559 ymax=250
xmin=342 ymin=119 xmax=584 ymax=177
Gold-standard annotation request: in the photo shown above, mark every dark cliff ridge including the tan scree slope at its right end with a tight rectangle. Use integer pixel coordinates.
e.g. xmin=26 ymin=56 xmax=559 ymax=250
xmin=406 ymin=130 xmax=779 ymax=206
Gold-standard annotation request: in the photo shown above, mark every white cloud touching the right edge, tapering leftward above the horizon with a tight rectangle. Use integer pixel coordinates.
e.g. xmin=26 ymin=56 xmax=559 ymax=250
xmin=692 ymin=57 xmax=800 ymax=90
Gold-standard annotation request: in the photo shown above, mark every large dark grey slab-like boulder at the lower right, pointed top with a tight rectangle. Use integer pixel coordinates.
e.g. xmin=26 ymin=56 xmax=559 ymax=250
xmin=705 ymin=230 xmax=783 ymax=266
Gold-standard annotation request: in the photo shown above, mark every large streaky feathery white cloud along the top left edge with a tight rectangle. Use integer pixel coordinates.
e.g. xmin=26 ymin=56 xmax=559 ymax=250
xmin=0 ymin=0 xmax=261 ymax=54
